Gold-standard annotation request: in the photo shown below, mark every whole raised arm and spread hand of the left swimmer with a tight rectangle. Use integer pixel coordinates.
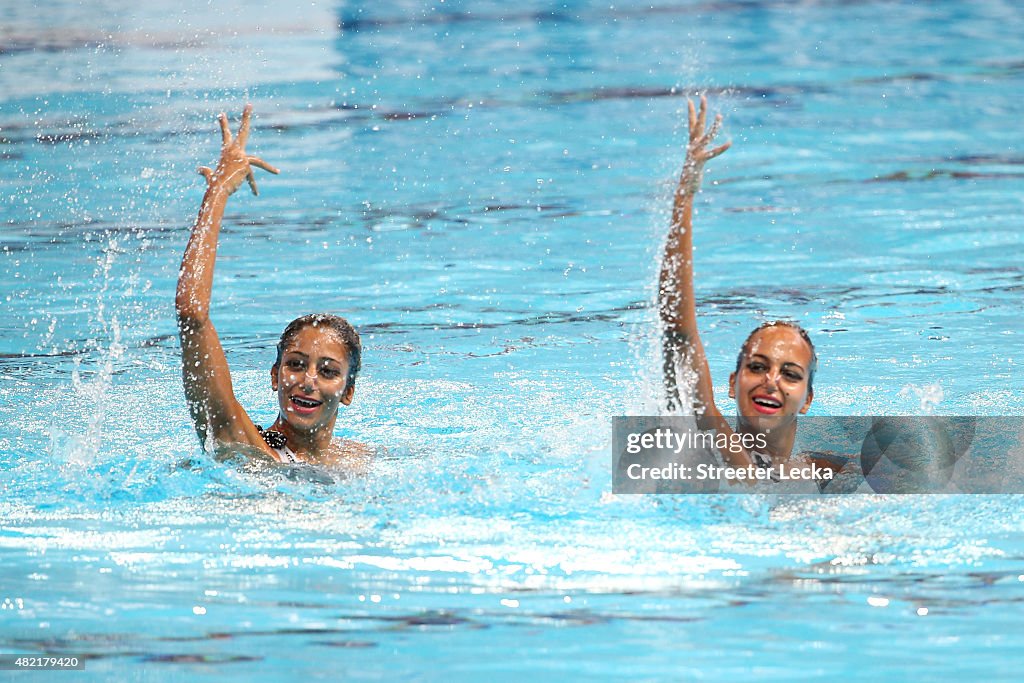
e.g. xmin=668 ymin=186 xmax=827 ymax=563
xmin=174 ymin=104 xmax=279 ymax=451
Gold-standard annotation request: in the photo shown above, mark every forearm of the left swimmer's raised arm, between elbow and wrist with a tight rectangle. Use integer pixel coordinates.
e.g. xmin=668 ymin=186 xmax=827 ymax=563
xmin=174 ymin=183 xmax=228 ymax=319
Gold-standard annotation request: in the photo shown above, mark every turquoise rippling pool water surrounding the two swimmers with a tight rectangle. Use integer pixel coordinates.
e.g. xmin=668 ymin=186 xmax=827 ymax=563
xmin=0 ymin=1 xmax=1024 ymax=681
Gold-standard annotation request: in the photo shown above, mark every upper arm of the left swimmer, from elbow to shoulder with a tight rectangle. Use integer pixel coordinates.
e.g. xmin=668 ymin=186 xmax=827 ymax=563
xmin=178 ymin=315 xmax=266 ymax=450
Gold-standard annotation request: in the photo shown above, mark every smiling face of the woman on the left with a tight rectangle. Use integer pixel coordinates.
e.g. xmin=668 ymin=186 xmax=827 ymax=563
xmin=270 ymin=326 xmax=355 ymax=432
